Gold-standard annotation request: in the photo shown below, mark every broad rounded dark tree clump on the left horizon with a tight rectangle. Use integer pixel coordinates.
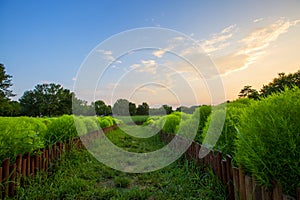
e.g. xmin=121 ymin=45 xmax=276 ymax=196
xmin=19 ymin=83 xmax=72 ymax=117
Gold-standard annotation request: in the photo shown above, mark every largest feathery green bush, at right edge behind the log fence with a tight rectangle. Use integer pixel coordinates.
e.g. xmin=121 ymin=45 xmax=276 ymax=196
xmin=235 ymin=88 xmax=300 ymax=195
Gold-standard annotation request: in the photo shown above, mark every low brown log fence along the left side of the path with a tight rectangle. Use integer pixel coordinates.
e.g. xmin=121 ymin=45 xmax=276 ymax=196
xmin=0 ymin=125 xmax=117 ymax=199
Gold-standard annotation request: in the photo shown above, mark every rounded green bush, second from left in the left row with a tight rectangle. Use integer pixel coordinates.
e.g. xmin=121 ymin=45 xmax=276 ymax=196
xmin=45 ymin=115 xmax=87 ymax=145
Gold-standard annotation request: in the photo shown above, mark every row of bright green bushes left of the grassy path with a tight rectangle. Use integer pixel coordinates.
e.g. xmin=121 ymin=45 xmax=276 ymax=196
xmin=0 ymin=115 xmax=121 ymax=161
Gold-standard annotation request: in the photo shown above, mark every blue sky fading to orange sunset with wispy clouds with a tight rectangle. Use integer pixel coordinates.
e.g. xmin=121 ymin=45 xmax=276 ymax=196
xmin=0 ymin=0 xmax=300 ymax=107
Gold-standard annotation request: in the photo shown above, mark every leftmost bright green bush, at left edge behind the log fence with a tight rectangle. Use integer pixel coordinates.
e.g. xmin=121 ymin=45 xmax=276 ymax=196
xmin=0 ymin=117 xmax=47 ymax=161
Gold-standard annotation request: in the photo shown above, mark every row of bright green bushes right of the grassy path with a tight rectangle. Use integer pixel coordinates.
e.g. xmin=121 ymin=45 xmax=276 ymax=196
xmin=146 ymin=88 xmax=300 ymax=195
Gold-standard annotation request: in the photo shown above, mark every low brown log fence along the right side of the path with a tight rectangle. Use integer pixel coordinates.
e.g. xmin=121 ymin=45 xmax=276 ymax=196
xmin=161 ymin=133 xmax=300 ymax=200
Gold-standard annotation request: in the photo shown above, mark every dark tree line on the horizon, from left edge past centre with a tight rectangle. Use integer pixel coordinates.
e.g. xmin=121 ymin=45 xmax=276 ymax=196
xmin=0 ymin=64 xmax=195 ymax=117
